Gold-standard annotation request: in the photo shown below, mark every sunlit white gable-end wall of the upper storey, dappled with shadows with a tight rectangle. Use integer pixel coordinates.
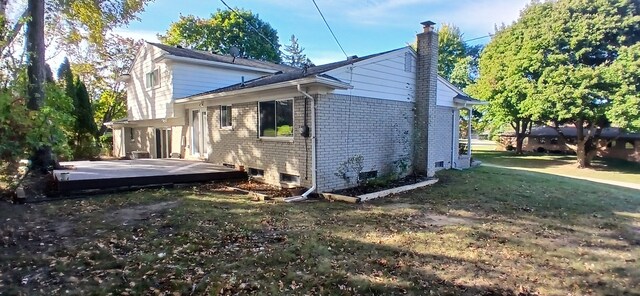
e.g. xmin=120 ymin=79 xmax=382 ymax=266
xmin=127 ymin=43 xmax=172 ymax=120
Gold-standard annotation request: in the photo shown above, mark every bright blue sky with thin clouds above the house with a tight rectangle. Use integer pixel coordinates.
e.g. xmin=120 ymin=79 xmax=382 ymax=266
xmin=117 ymin=0 xmax=529 ymax=64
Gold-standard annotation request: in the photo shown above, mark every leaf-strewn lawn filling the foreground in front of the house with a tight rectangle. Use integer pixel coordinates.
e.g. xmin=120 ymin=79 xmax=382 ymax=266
xmin=0 ymin=167 xmax=640 ymax=295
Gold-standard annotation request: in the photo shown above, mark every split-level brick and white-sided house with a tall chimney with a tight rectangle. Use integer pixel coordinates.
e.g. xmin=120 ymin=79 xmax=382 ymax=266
xmin=110 ymin=22 xmax=482 ymax=192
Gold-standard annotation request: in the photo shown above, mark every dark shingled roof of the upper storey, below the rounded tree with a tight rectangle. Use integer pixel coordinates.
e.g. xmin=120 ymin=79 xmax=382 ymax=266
xmin=148 ymin=42 xmax=296 ymax=71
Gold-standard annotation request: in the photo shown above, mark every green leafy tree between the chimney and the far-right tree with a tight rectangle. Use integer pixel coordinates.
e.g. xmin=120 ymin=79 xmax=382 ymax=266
xmin=467 ymin=3 xmax=552 ymax=154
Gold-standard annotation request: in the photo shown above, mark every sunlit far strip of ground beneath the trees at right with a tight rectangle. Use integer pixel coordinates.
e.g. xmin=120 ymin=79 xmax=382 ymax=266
xmin=473 ymin=151 xmax=640 ymax=184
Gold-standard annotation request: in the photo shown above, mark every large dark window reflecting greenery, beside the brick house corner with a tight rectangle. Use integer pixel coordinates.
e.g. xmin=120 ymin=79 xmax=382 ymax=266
xmin=258 ymin=99 xmax=293 ymax=137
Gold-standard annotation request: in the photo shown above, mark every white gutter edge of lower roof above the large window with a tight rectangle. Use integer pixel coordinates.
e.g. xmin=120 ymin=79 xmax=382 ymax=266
xmin=174 ymin=77 xmax=352 ymax=104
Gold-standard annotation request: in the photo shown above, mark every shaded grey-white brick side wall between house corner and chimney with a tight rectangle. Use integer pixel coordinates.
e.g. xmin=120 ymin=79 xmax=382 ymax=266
xmin=316 ymin=94 xmax=414 ymax=192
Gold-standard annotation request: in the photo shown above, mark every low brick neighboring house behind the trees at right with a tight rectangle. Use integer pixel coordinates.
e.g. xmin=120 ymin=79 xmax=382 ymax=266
xmin=500 ymin=126 xmax=640 ymax=162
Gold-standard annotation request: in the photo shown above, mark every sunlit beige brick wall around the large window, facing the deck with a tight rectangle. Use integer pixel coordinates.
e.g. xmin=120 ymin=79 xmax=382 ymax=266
xmin=207 ymin=98 xmax=312 ymax=187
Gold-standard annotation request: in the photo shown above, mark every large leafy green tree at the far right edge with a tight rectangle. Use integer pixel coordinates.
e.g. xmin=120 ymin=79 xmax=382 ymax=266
xmin=536 ymin=0 xmax=640 ymax=168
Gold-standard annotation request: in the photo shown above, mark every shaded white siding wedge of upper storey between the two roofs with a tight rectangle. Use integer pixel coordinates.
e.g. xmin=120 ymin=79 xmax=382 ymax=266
xmin=170 ymin=61 xmax=267 ymax=99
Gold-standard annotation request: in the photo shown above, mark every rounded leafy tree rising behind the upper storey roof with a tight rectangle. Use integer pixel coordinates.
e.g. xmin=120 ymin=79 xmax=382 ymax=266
xmin=159 ymin=9 xmax=281 ymax=63
